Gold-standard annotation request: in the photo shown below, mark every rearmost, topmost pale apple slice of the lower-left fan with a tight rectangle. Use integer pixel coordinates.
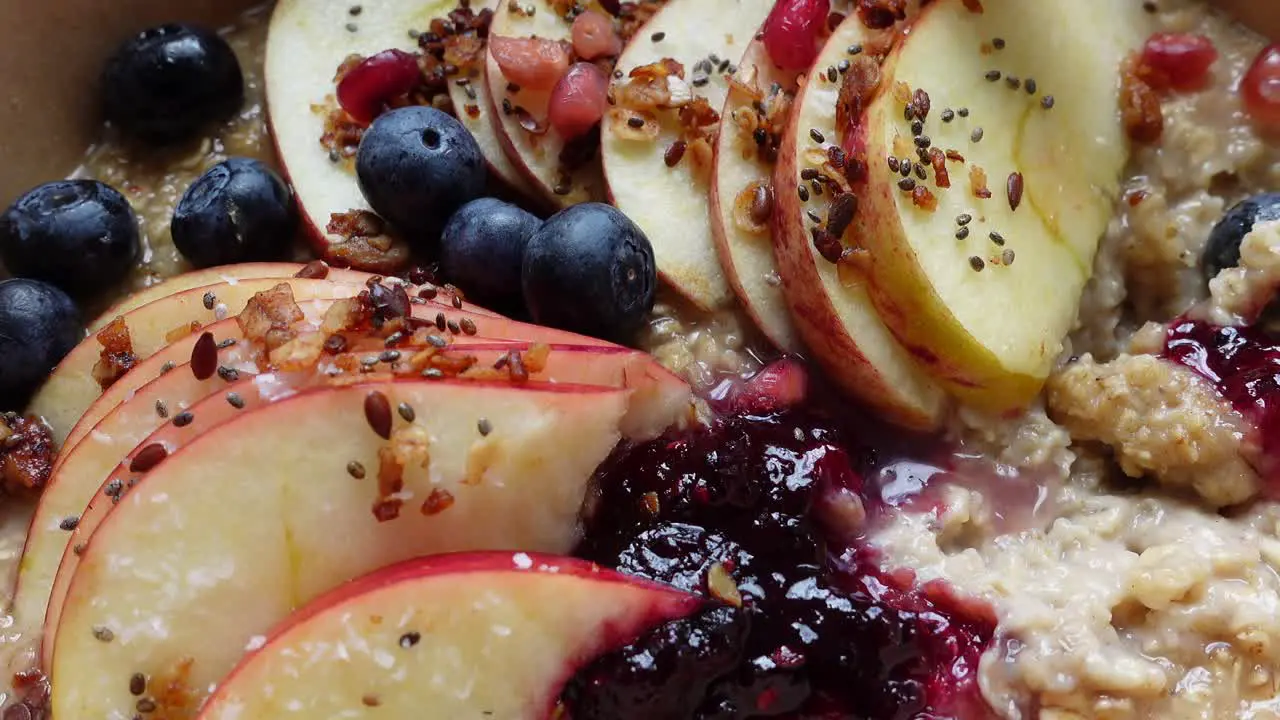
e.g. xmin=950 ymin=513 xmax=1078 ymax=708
xmin=29 ymin=278 xmax=364 ymax=445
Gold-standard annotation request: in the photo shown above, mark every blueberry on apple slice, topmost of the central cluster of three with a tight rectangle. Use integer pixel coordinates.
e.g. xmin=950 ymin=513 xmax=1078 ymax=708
xmin=356 ymin=106 xmax=486 ymax=243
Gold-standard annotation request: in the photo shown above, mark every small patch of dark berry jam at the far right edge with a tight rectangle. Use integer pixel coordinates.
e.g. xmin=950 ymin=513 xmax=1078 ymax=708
xmin=1165 ymin=320 xmax=1280 ymax=488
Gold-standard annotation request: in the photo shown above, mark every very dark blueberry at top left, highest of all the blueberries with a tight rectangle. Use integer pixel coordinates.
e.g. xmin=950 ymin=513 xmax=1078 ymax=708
xmin=101 ymin=24 xmax=244 ymax=143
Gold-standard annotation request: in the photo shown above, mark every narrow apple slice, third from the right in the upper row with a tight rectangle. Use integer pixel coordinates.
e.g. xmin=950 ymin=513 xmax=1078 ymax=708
xmin=710 ymin=40 xmax=803 ymax=352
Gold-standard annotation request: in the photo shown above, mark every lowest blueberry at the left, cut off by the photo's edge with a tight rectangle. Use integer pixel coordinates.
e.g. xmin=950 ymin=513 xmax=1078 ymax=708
xmin=0 ymin=278 xmax=84 ymax=409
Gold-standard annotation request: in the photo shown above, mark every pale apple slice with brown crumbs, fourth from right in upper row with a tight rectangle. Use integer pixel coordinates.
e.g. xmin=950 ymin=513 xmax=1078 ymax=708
xmin=600 ymin=0 xmax=773 ymax=310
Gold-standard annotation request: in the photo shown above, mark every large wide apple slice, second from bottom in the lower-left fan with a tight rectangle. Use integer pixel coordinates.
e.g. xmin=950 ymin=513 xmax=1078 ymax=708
xmin=50 ymin=375 xmax=645 ymax=717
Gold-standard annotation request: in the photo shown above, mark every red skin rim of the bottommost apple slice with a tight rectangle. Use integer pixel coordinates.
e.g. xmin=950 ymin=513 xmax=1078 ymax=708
xmin=197 ymin=552 xmax=707 ymax=720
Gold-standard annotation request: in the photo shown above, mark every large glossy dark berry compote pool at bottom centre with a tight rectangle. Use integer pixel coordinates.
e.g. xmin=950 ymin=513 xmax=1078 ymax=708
xmin=562 ymin=361 xmax=995 ymax=720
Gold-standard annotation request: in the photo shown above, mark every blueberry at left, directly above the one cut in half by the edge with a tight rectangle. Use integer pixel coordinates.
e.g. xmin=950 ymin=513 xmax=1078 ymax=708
xmin=0 ymin=181 xmax=141 ymax=297
